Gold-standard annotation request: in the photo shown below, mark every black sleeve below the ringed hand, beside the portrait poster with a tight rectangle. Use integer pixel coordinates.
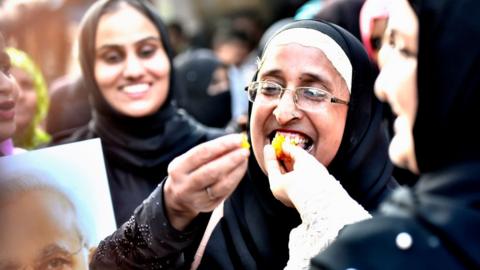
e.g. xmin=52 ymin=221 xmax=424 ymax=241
xmin=90 ymin=181 xmax=210 ymax=269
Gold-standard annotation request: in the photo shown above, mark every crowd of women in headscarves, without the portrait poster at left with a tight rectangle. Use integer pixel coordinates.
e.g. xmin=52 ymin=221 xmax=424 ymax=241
xmin=0 ymin=0 xmax=480 ymax=269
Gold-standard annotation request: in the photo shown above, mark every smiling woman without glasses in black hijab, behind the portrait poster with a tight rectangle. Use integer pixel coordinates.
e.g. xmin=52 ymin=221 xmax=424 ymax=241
xmin=52 ymin=0 xmax=223 ymax=225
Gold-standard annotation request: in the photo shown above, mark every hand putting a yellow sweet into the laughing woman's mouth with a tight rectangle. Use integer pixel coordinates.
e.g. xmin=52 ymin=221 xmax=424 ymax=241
xmin=264 ymin=142 xmax=331 ymax=212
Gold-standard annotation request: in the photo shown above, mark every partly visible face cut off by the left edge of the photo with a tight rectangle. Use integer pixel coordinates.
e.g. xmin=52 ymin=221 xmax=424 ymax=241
xmin=0 ymin=46 xmax=19 ymax=142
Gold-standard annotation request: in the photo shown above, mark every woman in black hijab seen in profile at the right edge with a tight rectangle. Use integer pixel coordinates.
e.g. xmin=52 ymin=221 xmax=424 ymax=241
xmin=312 ymin=0 xmax=480 ymax=269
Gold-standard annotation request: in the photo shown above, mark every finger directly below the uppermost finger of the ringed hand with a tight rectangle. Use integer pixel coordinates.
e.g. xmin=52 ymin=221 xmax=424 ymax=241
xmin=189 ymin=148 xmax=250 ymax=189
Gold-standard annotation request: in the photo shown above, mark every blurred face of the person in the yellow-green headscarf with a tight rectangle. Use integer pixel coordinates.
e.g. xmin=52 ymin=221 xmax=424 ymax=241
xmin=11 ymin=67 xmax=37 ymax=135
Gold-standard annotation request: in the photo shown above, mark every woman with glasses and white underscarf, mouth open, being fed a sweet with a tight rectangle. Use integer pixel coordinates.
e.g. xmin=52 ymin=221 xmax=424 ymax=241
xmin=91 ymin=21 xmax=394 ymax=269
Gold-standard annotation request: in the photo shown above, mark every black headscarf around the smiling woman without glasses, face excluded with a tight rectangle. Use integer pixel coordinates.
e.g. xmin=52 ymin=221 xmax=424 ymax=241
xmin=74 ymin=0 xmax=221 ymax=225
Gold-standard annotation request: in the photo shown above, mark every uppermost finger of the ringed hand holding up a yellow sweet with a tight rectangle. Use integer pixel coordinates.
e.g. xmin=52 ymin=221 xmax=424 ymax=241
xmin=168 ymin=134 xmax=242 ymax=173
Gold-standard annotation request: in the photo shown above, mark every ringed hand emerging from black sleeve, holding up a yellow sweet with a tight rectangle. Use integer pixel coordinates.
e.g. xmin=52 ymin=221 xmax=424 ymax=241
xmin=163 ymin=134 xmax=250 ymax=231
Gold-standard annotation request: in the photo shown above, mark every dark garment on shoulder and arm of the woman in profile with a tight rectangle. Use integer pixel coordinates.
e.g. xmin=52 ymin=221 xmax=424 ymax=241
xmin=312 ymin=162 xmax=480 ymax=269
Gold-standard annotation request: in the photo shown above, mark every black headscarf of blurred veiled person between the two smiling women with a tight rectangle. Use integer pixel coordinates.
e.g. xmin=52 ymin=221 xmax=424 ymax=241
xmin=174 ymin=49 xmax=232 ymax=128
